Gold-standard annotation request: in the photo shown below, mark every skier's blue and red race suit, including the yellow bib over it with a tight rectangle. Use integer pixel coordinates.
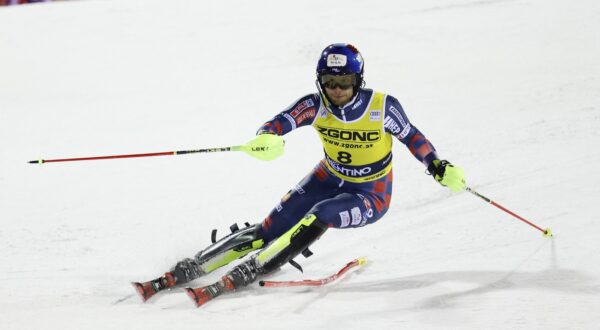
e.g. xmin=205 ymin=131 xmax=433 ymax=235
xmin=258 ymin=89 xmax=438 ymax=243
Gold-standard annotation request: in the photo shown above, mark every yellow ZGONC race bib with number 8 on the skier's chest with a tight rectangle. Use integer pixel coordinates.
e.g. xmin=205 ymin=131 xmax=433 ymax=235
xmin=313 ymin=92 xmax=392 ymax=182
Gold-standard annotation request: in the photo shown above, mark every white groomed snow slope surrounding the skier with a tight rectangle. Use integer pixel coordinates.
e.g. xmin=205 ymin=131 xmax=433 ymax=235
xmin=0 ymin=0 xmax=600 ymax=329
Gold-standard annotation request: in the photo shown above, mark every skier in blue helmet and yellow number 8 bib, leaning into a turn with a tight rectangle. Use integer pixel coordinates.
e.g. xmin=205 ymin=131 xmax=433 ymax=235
xmin=134 ymin=44 xmax=465 ymax=304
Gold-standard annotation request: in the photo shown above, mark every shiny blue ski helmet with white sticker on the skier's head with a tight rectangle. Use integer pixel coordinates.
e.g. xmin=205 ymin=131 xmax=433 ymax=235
xmin=317 ymin=43 xmax=364 ymax=93
